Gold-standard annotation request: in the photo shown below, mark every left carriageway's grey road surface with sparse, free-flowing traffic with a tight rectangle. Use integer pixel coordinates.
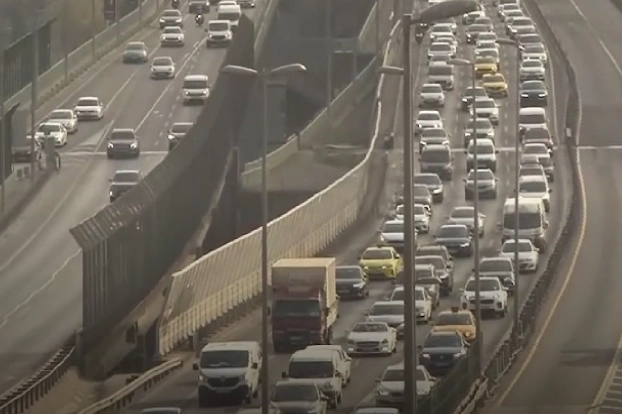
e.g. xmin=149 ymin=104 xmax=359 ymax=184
xmin=0 ymin=5 xmax=266 ymax=390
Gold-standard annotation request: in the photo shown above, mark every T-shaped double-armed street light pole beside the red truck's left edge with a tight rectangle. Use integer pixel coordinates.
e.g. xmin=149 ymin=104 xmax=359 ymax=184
xmin=221 ymin=63 xmax=307 ymax=414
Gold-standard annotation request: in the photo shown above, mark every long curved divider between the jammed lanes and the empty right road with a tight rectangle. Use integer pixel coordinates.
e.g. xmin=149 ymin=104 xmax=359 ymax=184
xmin=460 ymin=0 xmax=585 ymax=414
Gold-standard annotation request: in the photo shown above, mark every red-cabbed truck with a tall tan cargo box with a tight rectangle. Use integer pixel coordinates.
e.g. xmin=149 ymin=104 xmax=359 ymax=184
xmin=270 ymin=257 xmax=339 ymax=352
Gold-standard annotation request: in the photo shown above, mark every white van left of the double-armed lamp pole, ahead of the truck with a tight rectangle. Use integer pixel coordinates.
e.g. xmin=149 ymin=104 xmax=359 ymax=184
xmin=192 ymin=341 xmax=263 ymax=407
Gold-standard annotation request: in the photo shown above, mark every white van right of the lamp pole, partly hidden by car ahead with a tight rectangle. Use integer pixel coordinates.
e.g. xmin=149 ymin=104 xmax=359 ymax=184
xmin=282 ymin=349 xmax=342 ymax=408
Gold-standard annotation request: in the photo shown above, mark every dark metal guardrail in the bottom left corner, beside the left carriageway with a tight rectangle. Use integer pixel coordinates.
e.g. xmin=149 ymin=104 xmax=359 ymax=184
xmin=0 ymin=337 xmax=75 ymax=414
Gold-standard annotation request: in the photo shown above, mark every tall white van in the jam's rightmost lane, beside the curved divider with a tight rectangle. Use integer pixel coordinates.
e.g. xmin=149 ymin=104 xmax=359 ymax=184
xmin=500 ymin=197 xmax=549 ymax=248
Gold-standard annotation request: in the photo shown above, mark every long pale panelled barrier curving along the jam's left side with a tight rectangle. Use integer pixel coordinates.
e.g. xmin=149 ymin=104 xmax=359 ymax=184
xmin=159 ymin=20 xmax=398 ymax=354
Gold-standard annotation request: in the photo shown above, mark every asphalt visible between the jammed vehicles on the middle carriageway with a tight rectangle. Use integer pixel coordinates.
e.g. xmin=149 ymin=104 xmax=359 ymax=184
xmin=120 ymin=6 xmax=566 ymax=414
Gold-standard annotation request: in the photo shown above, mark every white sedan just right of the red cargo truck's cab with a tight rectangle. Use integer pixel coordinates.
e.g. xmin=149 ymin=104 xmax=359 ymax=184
xmin=346 ymin=321 xmax=397 ymax=356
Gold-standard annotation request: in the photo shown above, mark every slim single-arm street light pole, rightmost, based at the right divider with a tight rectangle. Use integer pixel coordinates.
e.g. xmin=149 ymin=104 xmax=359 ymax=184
xmin=497 ymin=39 xmax=522 ymax=341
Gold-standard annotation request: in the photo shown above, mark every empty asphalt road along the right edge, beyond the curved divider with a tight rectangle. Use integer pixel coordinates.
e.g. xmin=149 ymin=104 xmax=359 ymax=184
xmin=489 ymin=0 xmax=622 ymax=414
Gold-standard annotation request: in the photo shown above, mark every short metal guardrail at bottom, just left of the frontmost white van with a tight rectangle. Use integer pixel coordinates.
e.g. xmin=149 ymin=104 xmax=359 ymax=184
xmin=78 ymin=358 xmax=184 ymax=414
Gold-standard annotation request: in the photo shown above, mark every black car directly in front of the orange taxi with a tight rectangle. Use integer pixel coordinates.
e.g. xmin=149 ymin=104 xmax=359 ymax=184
xmin=417 ymin=331 xmax=469 ymax=376
